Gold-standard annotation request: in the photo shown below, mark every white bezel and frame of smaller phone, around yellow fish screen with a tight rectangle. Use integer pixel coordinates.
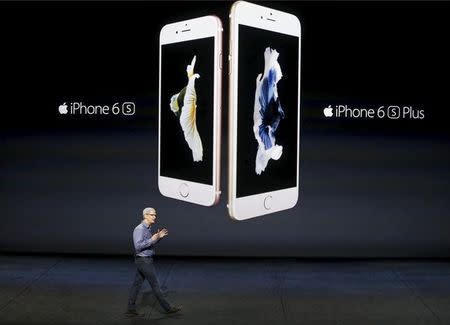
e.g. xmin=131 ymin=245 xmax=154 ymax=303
xmin=158 ymin=16 xmax=223 ymax=206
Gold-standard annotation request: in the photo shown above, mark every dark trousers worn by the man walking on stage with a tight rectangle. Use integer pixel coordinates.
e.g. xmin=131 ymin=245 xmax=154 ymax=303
xmin=128 ymin=257 xmax=170 ymax=311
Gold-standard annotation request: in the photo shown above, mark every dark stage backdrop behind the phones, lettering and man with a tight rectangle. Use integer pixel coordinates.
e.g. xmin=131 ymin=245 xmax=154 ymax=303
xmin=0 ymin=1 xmax=450 ymax=257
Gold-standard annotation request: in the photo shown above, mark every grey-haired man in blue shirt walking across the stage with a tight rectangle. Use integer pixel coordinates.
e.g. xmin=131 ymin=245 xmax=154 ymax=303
xmin=125 ymin=208 xmax=181 ymax=316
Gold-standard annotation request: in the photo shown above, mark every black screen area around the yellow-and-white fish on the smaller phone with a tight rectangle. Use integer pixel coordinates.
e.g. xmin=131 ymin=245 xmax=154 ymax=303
xmin=161 ymin=37 xmax=214 ymax=185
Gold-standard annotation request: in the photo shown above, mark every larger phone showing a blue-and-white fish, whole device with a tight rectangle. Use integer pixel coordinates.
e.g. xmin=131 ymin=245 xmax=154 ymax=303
xmin=228 ymin=1 xmax=301 ymax=220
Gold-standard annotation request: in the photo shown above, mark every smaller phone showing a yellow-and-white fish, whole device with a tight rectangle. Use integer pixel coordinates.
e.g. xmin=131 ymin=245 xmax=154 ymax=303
xmin=158 ymin=16 xmax=222 ymax=206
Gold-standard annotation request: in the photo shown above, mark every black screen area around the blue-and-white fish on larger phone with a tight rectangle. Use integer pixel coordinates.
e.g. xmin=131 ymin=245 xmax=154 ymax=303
xmin=236 ymin=25 xmax=299 ymax=197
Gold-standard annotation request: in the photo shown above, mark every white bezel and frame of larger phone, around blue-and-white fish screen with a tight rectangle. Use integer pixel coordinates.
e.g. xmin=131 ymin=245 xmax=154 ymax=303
xmin=228 ymin=1 xmax=301 ymax=220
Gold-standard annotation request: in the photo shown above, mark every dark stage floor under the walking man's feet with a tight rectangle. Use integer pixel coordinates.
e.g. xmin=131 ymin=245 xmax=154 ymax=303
xmin=0 ymin=255 xmax=450 ymax=325
